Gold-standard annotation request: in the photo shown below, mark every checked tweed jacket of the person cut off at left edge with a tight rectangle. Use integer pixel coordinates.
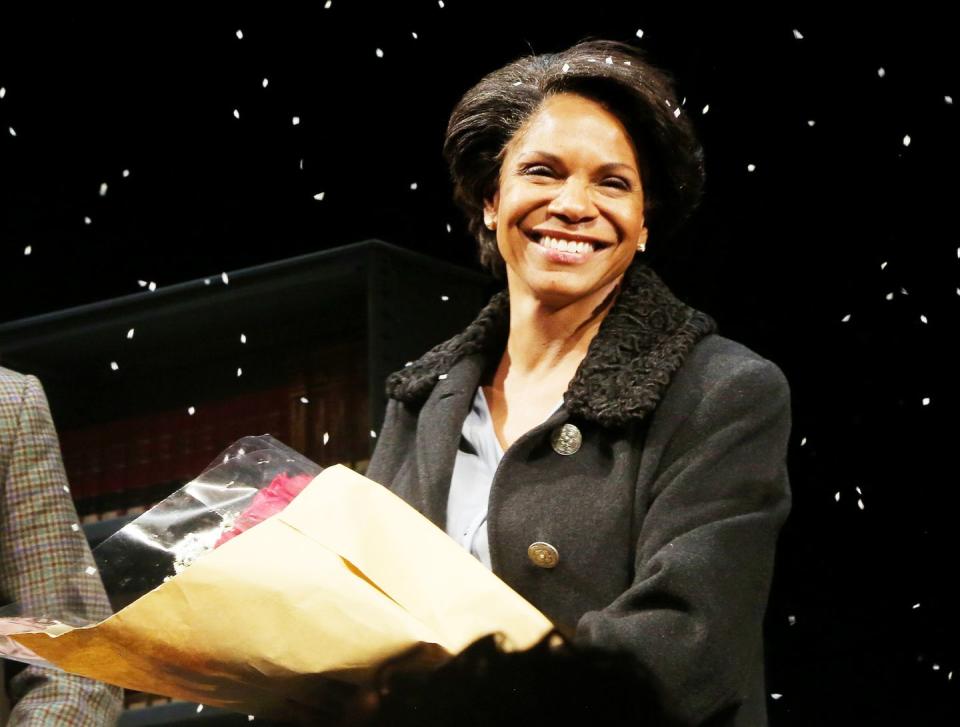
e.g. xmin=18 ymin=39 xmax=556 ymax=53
xmin=0 ymin=369 xmax=122 ymax=727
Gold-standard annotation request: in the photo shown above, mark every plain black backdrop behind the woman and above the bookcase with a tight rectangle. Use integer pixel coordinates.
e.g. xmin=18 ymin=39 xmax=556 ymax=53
xmin=0 ymin=7 xmax=960 ymax=726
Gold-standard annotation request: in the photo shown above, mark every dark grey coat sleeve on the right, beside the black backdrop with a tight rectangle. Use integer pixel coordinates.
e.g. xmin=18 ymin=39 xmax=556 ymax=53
xmin=576 ymin=358 xmax=791 ymax=725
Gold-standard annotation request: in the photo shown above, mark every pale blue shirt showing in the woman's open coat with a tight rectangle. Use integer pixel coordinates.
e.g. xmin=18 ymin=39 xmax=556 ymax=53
xmin=447 ymin=386 xmax=563 ymax=569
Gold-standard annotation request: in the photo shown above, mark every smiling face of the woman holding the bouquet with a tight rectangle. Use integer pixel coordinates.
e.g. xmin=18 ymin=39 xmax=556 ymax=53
xmin=484 ymin=94 xmax=647 ymax=307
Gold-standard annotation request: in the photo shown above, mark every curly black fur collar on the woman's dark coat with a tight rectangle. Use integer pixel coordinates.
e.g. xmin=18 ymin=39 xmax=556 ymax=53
xmin=387 ymin=263 xmax=717 ymax=427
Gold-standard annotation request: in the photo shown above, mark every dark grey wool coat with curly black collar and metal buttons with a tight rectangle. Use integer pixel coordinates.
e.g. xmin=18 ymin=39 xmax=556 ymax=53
xmin=367 ymin=263 xmax=791 ymax=727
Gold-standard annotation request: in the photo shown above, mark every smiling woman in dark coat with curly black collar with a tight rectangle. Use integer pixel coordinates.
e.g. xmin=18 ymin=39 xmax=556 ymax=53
xmin=367 ymin=41 xmax=790 ymax=726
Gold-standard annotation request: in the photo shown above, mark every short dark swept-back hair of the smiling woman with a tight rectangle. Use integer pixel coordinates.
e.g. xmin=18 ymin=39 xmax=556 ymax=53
xmin=443 ymin=40 xmax=704 ymax=278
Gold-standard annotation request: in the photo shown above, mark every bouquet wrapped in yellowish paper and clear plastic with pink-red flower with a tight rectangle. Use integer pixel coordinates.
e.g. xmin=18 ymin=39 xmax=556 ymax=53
xmin=0 ymin=436 xmax=552 ymax=719
